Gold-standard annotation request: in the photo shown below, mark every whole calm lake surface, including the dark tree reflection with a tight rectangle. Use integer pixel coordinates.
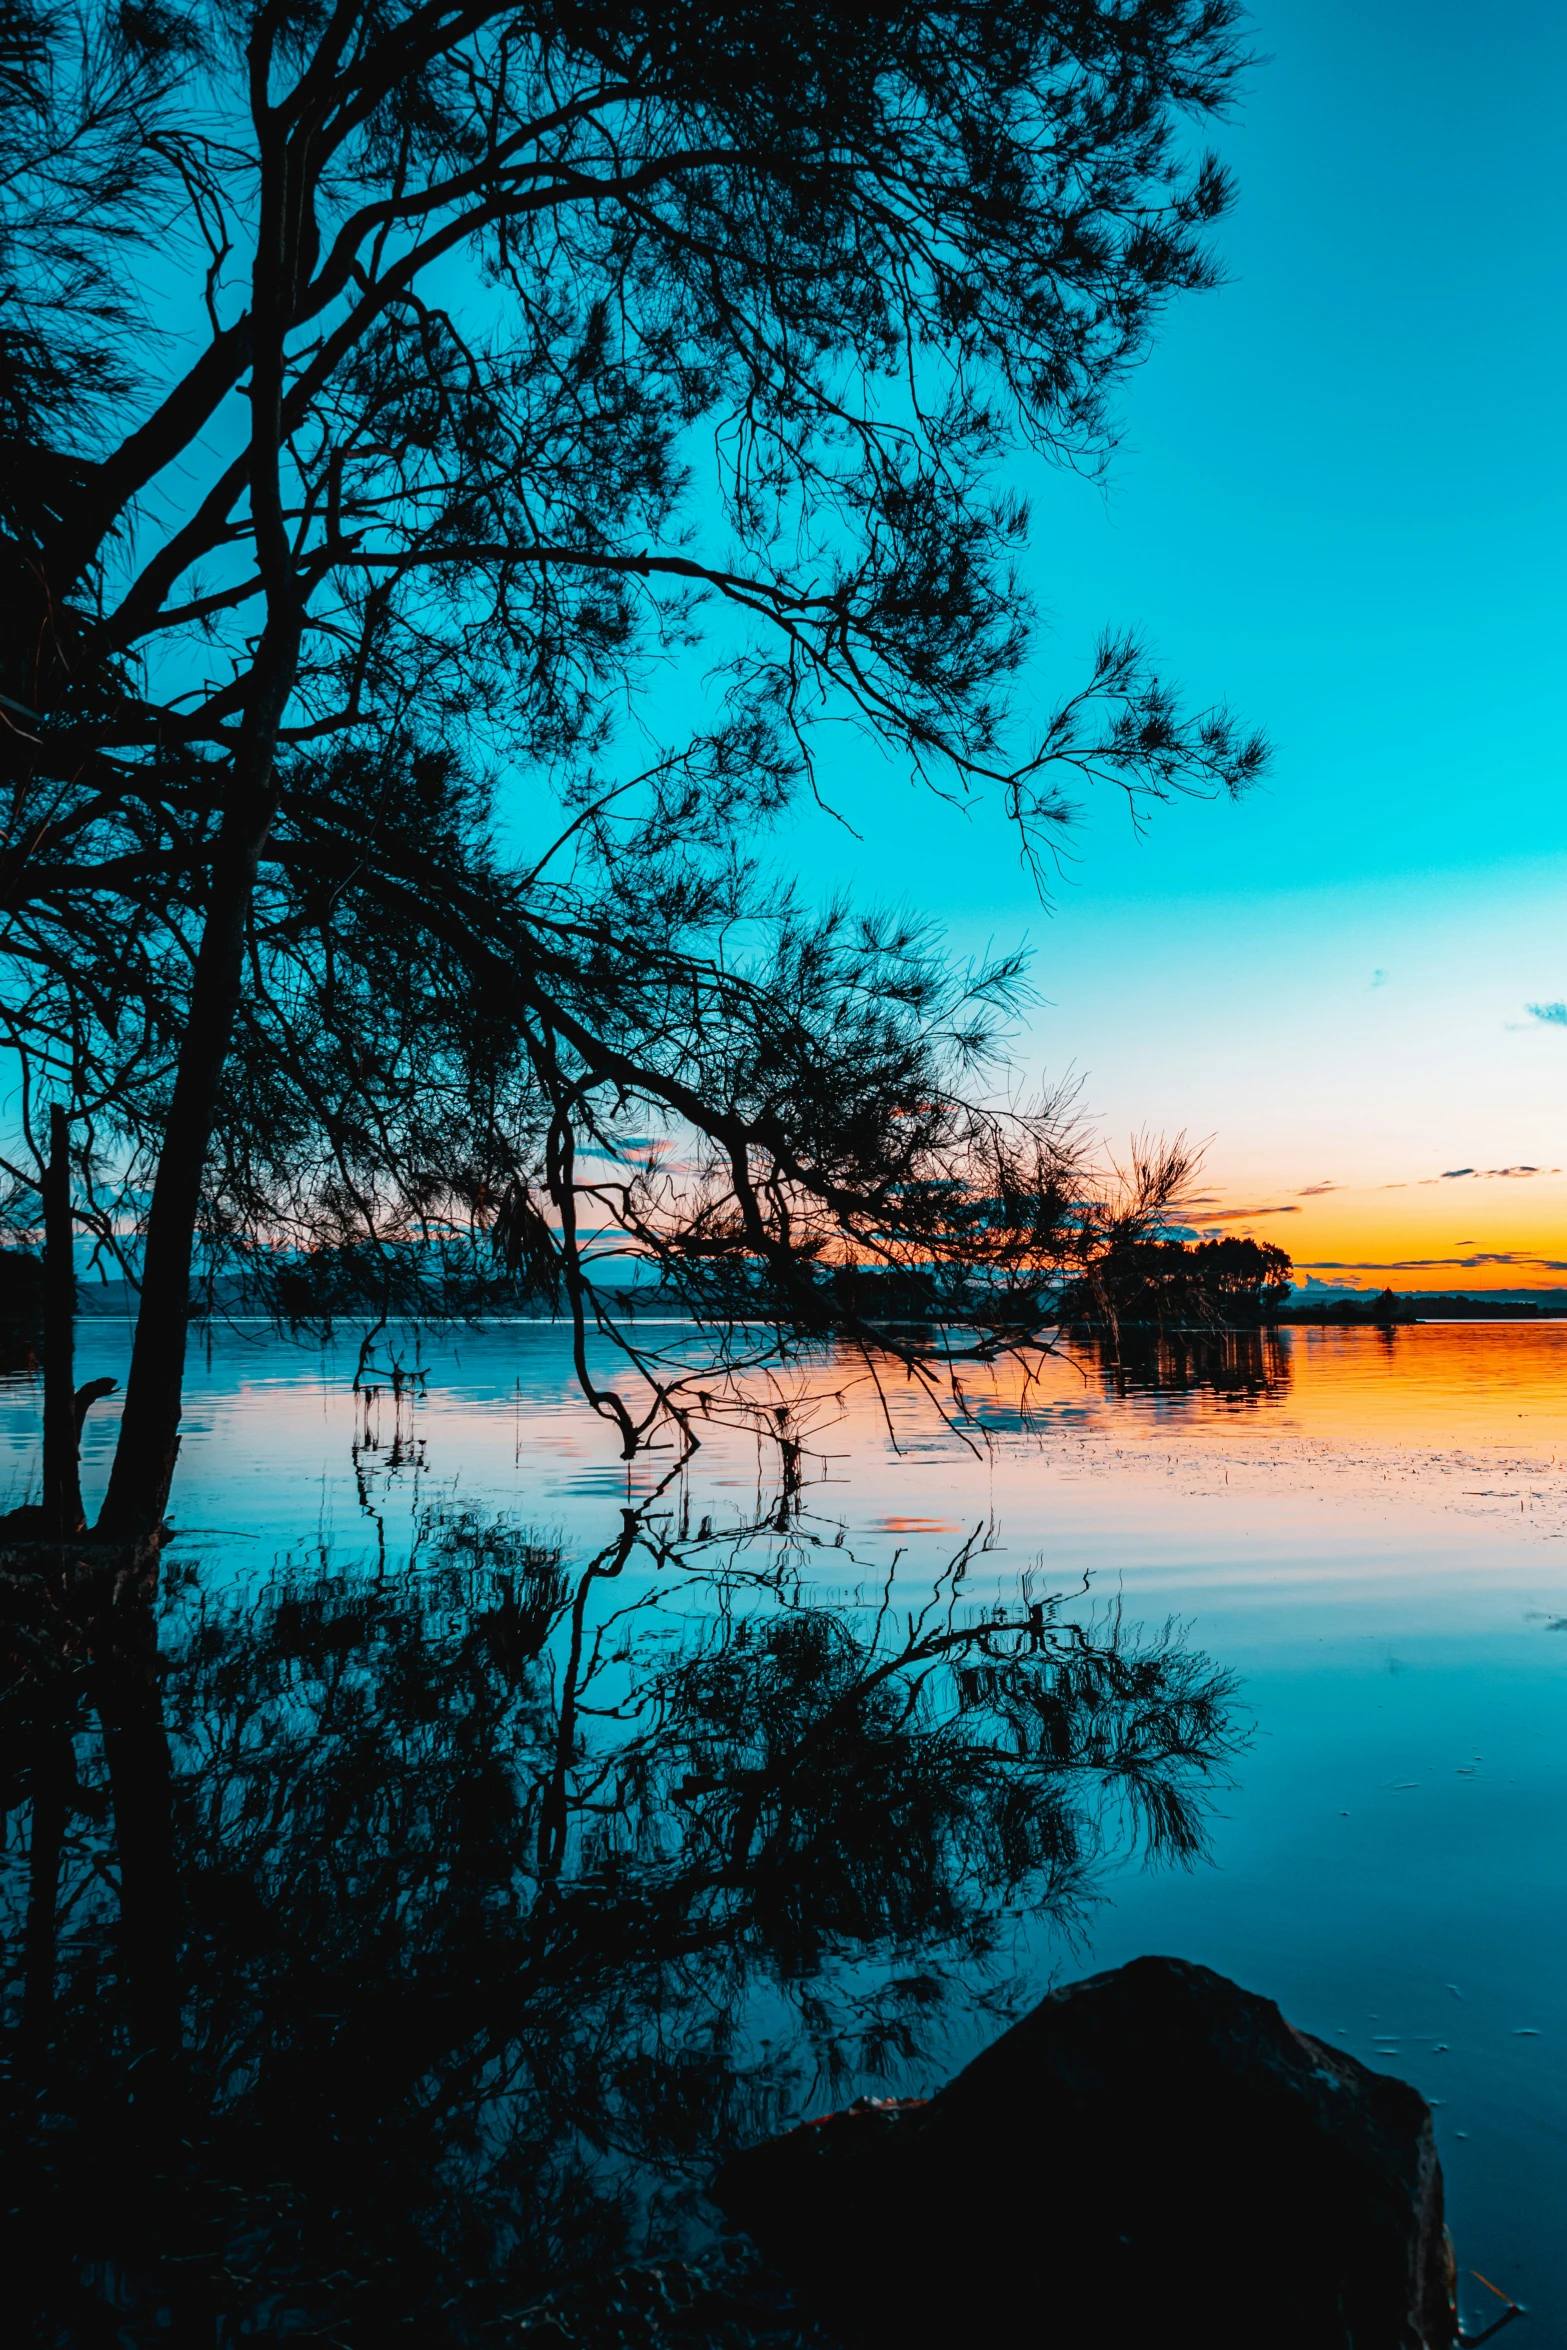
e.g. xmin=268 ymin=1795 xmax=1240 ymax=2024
xmin=0 ymin=1323 xmax=1567 ymax=2350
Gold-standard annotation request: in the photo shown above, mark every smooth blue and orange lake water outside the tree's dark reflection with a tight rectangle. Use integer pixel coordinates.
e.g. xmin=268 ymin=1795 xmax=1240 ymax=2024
xmin=0 ymin=1323 xmax=1567 ymax=2322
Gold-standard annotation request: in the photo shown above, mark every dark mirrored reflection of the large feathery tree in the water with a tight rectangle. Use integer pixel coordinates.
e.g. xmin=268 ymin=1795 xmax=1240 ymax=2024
xmin=2 ymin=1504 xmax=1233 ymax=2343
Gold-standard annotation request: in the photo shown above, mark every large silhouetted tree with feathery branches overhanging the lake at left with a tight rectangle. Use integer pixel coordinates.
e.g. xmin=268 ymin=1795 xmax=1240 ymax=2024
xmin=0 ymin=0 xmax=1262 ymax=1537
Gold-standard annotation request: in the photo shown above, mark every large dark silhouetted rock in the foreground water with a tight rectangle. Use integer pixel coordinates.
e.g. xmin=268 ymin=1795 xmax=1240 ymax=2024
xmin=712 ymin=1958 xmax=1457 ymax=2350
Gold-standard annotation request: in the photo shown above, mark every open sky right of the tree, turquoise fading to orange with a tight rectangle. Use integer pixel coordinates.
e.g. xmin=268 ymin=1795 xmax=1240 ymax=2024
xmin=789 ymin=0 xmax=1567 ymax=1290
